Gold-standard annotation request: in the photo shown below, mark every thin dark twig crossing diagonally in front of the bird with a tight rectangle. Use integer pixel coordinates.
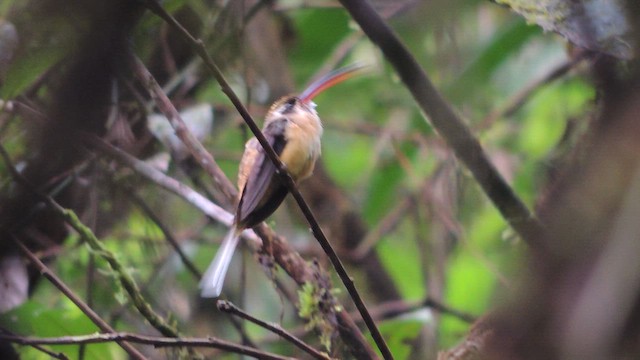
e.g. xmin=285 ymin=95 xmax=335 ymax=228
xmin=141 ymin=0 xmax=393 ymax=359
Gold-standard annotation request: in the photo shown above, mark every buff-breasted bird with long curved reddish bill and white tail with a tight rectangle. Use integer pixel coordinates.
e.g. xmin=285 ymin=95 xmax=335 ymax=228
xmin=200 ymin=64 xmax=362 ymax=298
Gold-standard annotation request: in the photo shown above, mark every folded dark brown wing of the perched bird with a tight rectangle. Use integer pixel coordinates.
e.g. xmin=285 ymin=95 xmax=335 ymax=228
xmin=236 ymin=118 xmax=287 ymax=228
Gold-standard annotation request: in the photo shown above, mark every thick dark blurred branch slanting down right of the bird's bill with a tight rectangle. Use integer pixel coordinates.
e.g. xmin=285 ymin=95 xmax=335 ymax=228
xmin=340 ymin=0 xmax=548 ymax=254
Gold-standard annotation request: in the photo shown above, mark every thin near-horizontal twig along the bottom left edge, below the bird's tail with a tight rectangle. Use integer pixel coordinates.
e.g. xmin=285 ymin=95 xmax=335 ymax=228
xmin=0 ymin=333 xmax=293 ymax=360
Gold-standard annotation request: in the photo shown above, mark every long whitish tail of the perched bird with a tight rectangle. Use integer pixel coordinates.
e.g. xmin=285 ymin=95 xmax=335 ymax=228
xmin=200 ymin=226 xmax=241 ymax=298
